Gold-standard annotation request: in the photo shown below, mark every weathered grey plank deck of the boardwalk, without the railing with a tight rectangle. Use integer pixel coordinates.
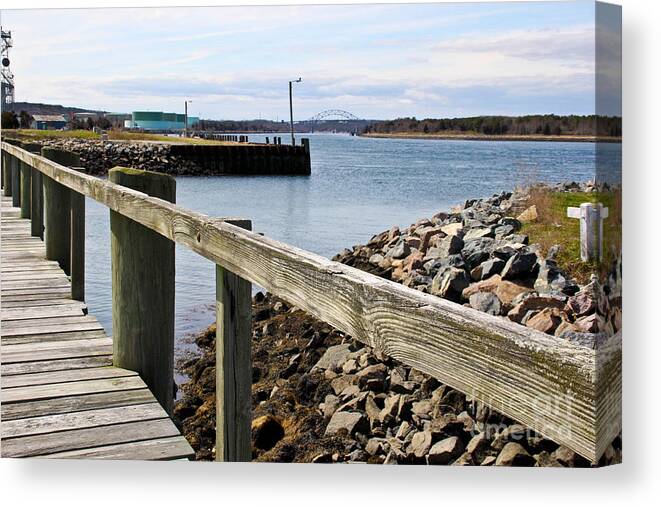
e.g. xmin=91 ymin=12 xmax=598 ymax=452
xmin=0 ymin=197 xmax=193 ymax=459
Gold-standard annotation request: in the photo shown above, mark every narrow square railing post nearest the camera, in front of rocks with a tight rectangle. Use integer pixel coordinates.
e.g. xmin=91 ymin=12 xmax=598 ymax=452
xmin=216 ymin=220 xmax=252 ymax=461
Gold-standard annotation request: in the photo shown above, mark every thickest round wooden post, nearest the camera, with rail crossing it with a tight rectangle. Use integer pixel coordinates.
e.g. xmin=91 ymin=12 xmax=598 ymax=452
xmin=108 ymin=167 xmax=176 ymax=414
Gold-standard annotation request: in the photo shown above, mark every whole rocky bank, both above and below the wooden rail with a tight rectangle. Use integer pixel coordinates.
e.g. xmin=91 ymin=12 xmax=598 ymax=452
xmin=176 ymin=186 xmax=622 ymax=466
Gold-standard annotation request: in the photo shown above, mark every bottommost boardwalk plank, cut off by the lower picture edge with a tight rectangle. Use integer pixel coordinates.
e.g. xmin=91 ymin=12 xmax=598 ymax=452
xmin=46 ymin=437 xmax=195 ymax=460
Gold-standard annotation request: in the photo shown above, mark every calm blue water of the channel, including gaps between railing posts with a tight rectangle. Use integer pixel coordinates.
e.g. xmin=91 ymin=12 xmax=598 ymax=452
xmin=86 ymin=135 xmax=621 ymax=358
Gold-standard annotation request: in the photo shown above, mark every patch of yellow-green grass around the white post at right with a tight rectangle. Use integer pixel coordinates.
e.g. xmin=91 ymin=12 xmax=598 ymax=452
xmin=522 ymin=187 xmax=622 ymax=284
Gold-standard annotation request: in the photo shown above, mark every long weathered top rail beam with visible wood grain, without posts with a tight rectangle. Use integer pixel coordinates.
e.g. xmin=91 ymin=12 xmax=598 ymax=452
xmin=3 ymin=141 xmax=619 ymax=461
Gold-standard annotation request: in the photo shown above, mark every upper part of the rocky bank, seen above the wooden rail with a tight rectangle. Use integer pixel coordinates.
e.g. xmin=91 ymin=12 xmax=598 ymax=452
xmin=334 ymin=185 xmax=622 ymax=347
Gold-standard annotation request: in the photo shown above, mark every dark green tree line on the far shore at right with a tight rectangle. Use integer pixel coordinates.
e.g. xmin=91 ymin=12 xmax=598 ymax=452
xmin=363 ymin=114 xmax=622 ymax=137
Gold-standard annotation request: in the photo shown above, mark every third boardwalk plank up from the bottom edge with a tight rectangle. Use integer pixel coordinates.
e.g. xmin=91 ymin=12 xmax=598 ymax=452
xmin=0 ymin=400 xmax=168 ymax=439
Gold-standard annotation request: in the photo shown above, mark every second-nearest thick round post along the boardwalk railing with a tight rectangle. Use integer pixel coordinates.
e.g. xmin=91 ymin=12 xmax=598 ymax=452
xmin=41 ymin=146 xmax=80 ymax=275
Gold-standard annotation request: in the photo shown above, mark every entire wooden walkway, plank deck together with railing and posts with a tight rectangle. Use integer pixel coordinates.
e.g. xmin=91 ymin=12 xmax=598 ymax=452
xmin=0 ymin=142 xmax=621 ymax=462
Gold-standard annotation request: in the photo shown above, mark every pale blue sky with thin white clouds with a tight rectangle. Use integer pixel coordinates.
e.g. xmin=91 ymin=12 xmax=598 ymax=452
xmin=1 ymin=0 xmax=608 ymax=120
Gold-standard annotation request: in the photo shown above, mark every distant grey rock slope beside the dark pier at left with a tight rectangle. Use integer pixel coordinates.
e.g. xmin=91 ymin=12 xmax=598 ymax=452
xmin=29 ymin=138 xmax=206 ymax=176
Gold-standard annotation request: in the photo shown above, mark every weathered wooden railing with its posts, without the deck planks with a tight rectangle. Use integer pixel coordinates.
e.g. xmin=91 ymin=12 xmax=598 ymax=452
xmin=2 ymin=143 xmax=621 ymax=461
